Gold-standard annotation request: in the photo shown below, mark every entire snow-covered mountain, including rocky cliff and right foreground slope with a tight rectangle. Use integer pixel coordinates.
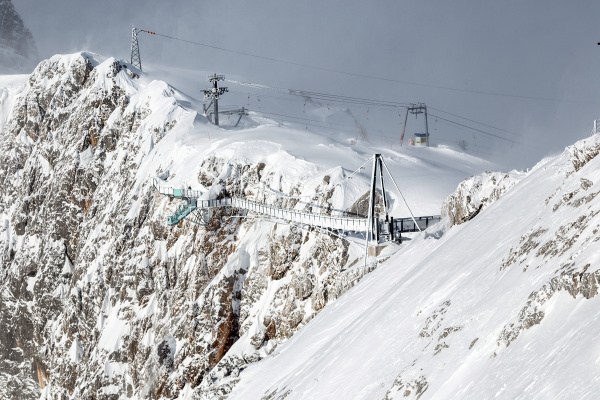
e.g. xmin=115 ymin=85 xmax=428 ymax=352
xmin=0 ymin=53 xmax=599 ymax=399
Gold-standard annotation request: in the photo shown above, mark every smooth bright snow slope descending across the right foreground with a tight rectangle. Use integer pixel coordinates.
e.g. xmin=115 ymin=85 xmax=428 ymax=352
xmin=230 ymin=135 xmax=600 ymax=399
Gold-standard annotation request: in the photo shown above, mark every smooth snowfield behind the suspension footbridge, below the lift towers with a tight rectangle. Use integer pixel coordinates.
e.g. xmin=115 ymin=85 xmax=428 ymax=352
xmin=125 ymin=64 xmax=497 ymax=217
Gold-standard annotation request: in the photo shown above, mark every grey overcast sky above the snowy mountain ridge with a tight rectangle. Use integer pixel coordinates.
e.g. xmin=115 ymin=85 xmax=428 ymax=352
xmin=13 ymin=0 xmax=600 ymax=167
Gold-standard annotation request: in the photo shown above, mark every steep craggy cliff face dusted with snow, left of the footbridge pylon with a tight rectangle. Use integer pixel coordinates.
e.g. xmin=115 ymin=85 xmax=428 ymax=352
xmin=0 ymin=53 xmax=376 ymax=399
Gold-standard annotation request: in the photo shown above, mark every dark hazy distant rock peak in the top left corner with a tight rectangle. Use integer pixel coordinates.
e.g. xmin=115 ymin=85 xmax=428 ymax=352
xmin=0 ymin=0 xmax=37 ymax=73
